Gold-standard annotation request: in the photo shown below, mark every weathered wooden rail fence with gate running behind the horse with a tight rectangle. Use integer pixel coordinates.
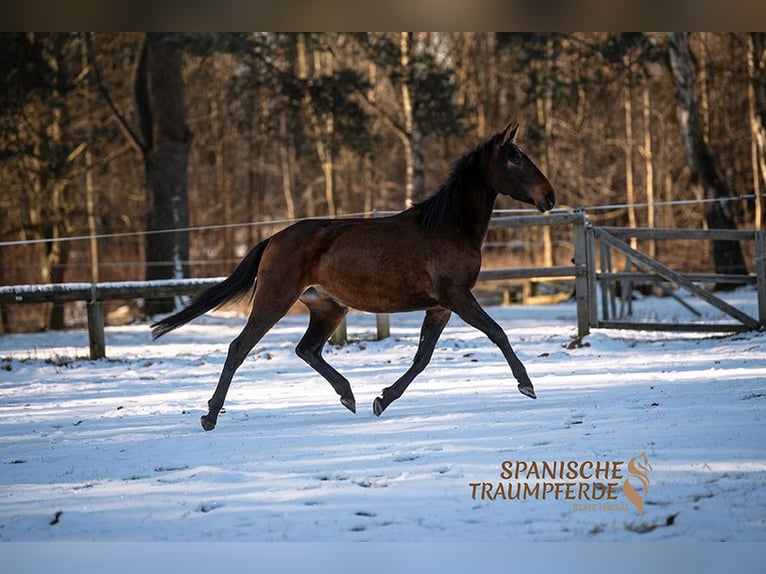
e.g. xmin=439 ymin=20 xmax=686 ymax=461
xmin=0 ymin=210 xmax=766 ymax=359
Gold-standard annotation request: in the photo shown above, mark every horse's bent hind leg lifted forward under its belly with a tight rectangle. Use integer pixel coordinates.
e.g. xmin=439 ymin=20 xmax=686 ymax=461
xmin=295 ymin=289 xmax=356 ymax=413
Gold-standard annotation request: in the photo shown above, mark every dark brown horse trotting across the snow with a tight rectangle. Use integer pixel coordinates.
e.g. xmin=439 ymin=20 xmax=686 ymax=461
xmin=152 ymin=125 xmax=556 ymax=430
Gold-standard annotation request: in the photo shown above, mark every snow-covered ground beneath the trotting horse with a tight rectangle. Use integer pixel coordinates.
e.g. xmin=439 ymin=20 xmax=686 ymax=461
xmin=0 ymin=290 xmax=766 ymax=542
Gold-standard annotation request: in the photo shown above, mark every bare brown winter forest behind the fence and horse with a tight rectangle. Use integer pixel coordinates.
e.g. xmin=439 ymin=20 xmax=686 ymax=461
xmin=0 ymin=32 xmax=766 ymax=333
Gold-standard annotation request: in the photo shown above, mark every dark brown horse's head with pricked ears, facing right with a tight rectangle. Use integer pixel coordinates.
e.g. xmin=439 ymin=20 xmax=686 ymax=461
xmin=487 ymin=124 xmax=556 ymax=212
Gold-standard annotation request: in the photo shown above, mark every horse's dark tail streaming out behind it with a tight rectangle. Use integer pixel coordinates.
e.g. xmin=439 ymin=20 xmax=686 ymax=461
xmin=152 ymin=239 xmax=269 ymax=339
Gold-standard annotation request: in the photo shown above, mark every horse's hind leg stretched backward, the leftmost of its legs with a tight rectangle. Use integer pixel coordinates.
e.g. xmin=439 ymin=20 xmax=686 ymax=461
xmin=200 ymin=290 xmax=298 ymax=431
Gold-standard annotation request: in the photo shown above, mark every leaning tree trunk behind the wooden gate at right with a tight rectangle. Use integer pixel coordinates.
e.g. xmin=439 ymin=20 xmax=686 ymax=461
xmin=669 ymin=32 xmax=747 ymax=289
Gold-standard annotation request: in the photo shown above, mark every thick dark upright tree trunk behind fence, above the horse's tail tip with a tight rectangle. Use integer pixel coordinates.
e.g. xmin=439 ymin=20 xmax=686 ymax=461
xmin=136 ymin=33 xmax=191 ymax=316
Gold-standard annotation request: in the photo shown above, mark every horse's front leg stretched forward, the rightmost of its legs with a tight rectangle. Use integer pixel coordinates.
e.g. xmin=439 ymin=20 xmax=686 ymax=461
xmin=446 ymin=289 xmax=537 ymax=399
